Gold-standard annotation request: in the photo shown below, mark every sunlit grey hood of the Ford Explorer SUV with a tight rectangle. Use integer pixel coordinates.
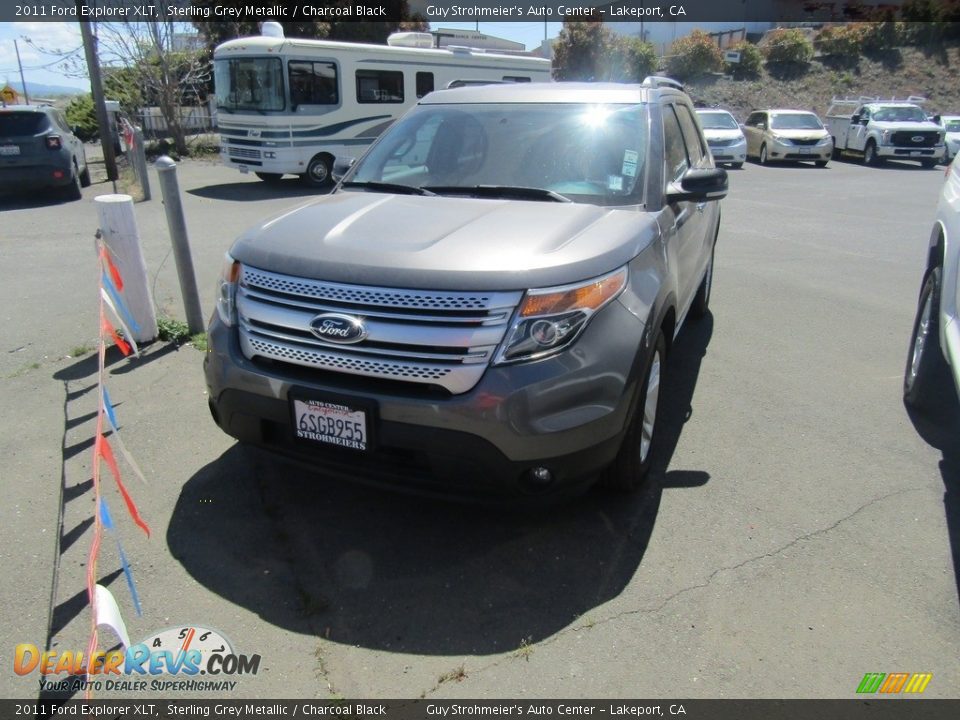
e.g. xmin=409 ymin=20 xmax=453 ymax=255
xmin=230 ymin=191 xmax=658 ymax=291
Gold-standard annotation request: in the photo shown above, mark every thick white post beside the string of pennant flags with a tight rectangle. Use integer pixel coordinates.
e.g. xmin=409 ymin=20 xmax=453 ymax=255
xmin=94 ymin=195 xmax=157 ymax=343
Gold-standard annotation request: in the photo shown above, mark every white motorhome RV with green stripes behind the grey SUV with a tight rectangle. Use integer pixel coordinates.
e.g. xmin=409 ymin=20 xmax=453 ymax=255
xmin=213 ymin=23 xmax=550 ymax=186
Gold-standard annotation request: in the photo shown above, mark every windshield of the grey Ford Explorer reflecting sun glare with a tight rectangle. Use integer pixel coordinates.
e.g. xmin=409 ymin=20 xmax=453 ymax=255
xmin=346 ymin=103 xmax=647 ymax=205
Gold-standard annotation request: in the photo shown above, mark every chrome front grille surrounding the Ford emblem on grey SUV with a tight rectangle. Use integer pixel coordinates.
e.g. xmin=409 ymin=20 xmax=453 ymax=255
xmin=237 ymin=267 xmax=521 ymax=394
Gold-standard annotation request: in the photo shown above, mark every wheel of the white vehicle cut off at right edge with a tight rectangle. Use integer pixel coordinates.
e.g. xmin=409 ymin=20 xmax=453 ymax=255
xmin=903 ymin=267 xmax=953 ymax=409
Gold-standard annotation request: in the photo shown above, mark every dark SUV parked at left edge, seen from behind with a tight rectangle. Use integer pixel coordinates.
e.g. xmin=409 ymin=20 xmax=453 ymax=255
xmin=0 ymin=105 xmax=90 ymax=200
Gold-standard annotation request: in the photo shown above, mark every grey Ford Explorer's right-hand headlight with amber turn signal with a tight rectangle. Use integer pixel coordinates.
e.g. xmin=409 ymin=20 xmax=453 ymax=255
xmin=494 ymin=267 xmax=627 ymax=365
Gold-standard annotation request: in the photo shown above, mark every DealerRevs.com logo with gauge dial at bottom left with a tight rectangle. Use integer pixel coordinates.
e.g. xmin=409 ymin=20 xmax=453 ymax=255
xmin=13 ymin=627 xmax=260 ymax=692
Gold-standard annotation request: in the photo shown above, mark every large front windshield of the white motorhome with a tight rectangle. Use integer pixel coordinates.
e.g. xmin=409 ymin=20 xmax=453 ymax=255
xmin=213 ymin=57 xmax=285 ymax=112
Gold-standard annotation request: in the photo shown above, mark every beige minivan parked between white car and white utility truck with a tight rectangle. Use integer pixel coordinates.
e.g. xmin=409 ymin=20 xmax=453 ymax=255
xmin=743 ymin=110 xmax=833 ymax=168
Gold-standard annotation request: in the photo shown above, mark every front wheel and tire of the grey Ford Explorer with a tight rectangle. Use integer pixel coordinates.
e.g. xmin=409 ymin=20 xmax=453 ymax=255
xmin=600 ymin=332 xmax=666 ymax=491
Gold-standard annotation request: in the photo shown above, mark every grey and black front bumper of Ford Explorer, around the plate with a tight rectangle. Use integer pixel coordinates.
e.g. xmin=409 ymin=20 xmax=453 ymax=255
xmin=204 ymin=301 xmax=644 ymax=497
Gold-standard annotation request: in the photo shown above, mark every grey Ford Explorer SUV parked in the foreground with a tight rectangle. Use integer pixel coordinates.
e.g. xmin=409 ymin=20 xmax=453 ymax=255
xmin=204 ymin=78 xmax=727 ymax=496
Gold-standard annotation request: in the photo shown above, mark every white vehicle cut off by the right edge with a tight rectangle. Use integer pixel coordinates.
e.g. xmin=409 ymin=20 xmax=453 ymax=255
xmin=903 ymin=156 xmax=960 ymax=410
